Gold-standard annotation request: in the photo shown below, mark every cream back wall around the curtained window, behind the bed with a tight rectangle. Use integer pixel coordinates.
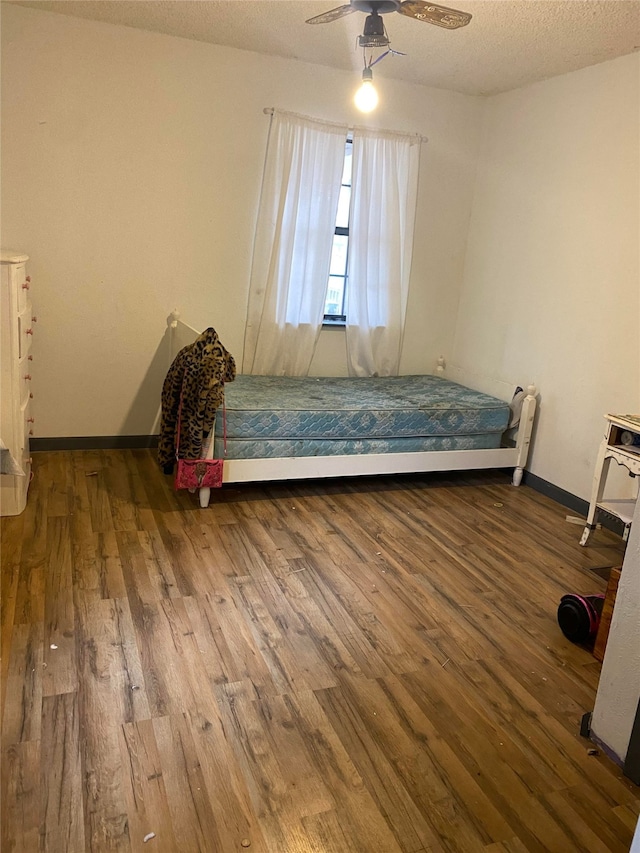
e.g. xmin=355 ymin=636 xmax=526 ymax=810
xmin=1 ymin=4 xmax=483 ymax=437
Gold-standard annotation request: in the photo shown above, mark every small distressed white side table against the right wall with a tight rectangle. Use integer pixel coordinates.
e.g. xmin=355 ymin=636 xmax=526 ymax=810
xmin=580 ymin=415 xmax=640 ymax=545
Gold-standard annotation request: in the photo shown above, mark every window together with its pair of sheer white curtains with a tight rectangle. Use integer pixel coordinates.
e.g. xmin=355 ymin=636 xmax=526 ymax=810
xmin=242 ymin=110 xmax=421 ymax=376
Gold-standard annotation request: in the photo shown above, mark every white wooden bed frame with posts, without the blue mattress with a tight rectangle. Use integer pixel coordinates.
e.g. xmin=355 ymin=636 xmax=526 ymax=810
xmin=168 ymin=311 xmax=536 ymax=507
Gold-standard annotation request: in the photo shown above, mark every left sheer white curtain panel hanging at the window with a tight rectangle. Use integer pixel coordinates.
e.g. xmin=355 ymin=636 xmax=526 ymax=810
xmin=242 ymin=112 xmax=347 ymax=376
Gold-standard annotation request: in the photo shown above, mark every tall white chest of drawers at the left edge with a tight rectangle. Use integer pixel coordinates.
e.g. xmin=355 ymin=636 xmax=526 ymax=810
xmin=0 ymin=250 xmax=36 ymax=515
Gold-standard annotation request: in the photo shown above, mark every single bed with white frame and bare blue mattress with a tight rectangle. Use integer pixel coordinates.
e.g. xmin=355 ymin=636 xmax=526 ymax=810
xmin=169 ymin=312 xmax=536 ymax=507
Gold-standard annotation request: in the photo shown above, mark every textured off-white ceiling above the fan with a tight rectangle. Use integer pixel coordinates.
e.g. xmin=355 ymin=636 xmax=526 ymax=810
xmin=3 ymin=0 xmax=640 ymax=95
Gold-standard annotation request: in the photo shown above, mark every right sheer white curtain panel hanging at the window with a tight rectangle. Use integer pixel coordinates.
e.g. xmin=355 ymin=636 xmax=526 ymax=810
xmin=345 ymin=130 xmax=421 ymax=376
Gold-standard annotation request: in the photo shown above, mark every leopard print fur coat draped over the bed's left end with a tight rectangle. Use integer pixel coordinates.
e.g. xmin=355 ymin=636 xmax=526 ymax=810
xmin=158 ymin=329 xmax=236 ymax=470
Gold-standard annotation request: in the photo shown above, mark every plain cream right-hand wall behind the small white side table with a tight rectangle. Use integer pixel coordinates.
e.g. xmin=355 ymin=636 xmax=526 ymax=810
xmin=453 ymin=54 xmax=640 ymax=499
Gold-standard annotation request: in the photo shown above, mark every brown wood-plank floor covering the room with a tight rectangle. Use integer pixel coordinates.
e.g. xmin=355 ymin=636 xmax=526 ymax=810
xmin=2 ymin=450 xmax=640 ymax=853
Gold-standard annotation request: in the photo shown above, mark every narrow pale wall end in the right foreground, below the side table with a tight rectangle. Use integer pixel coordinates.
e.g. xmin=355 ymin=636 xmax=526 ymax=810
xmin=591 ymin=492 xmax=640 ymax=764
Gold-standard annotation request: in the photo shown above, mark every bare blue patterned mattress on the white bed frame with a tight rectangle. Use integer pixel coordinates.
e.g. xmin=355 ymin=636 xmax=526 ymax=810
xmin=215 ymin=375 xmax=509 ymax=459
